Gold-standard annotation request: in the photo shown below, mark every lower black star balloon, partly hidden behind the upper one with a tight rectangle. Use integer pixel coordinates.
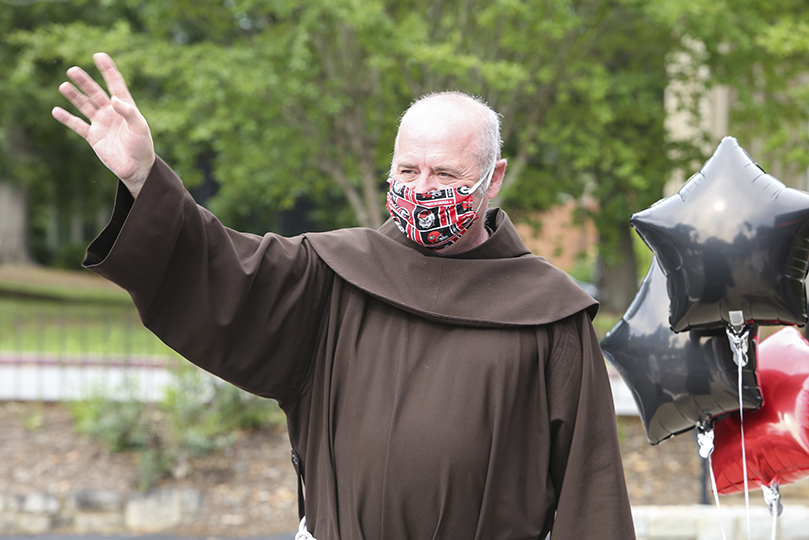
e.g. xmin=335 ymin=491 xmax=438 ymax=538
xmin=601 ymin=260 xmax=761 ymax=444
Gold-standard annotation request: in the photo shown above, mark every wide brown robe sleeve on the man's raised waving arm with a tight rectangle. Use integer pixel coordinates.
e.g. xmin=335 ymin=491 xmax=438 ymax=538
xmin=84 ymin=158 xmax=331 ymax=406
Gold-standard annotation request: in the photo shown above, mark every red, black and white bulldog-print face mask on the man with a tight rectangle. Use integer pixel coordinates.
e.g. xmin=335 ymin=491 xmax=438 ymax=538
xmin=387 ymin=171 xmax=494 ymax=249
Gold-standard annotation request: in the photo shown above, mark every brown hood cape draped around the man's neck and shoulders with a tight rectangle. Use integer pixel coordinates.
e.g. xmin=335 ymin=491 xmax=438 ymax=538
xmin=305 ymin=208 xmax=598 ymax=326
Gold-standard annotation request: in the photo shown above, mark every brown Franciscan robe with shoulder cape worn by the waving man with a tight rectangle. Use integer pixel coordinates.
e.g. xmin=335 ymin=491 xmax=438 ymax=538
xmin=85 ymin=160 xmax=634 ymax=540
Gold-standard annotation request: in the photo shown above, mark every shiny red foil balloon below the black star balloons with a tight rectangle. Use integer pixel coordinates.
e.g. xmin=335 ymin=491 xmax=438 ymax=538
xmin=711 ymin=327 xmax=809 ymax=494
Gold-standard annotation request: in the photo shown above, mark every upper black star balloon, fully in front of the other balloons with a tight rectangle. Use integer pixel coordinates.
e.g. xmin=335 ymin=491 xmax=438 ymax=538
xmin=630 ymin=137 xmax=809 ymax=332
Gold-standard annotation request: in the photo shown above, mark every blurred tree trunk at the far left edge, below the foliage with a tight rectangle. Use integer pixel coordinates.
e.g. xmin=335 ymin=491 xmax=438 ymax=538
xmin=0 ymin=180 xmax=32 ymax=264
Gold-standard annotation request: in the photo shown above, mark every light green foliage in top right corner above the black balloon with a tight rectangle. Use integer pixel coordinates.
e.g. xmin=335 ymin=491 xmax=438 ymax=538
xmin=650 ymin=0 xmax=809 ymax=181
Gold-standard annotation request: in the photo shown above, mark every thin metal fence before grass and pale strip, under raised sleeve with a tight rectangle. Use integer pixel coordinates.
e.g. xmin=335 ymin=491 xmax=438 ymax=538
xmin=0 ymin=310 xmax=179 ymax=401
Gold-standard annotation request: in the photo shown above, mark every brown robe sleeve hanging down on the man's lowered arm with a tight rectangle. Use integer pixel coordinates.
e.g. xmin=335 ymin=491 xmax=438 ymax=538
xmin=546 ymin=313 xmax=635 ymax=540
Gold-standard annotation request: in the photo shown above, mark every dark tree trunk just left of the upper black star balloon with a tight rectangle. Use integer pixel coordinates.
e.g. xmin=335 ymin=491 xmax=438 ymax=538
xmin=598 ymin=225 xmax=638 ymax=315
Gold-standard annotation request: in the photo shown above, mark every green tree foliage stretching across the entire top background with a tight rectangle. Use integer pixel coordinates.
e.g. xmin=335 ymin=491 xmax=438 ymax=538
xmin=0 ymin=0 xmax=809 ymax=308
